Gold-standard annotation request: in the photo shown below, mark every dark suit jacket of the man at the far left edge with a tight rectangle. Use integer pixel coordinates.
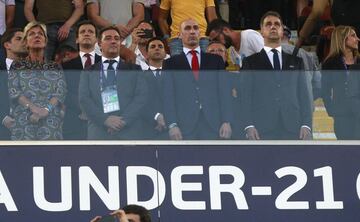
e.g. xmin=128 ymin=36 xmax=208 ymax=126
xmin=0 ymin=62 xmax=10 ymax=140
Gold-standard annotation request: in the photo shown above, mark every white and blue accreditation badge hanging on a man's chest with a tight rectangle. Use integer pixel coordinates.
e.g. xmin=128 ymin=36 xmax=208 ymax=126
xmin=101 ymin=86 xmax=120 ymax=113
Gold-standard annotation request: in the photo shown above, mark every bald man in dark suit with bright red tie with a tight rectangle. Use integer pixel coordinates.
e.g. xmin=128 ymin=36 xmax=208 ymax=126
xmin=163 ymin=19 xmax=232 ymax=140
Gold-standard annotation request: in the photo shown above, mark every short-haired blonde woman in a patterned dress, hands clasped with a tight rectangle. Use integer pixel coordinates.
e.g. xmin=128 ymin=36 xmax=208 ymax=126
xmin=9 ymin=22 xmax=66 ymax=140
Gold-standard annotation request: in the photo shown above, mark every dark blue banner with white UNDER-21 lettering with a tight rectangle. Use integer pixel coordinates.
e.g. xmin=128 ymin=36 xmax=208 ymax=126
xmin=0 ymin=145 xmax=360 ymax=222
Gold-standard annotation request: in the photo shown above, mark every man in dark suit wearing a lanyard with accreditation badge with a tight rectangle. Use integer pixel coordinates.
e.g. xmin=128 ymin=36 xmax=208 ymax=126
xmin=79 ymin=26 xmax=147 ymax=140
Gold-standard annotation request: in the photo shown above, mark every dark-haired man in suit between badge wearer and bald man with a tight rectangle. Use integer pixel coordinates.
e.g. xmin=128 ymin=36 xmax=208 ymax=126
xmin=143 ymin=37 xmax=169 ymax=140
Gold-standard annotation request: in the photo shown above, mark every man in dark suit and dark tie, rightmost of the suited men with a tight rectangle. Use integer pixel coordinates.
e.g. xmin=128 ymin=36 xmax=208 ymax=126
xmin=241 ymin=11 xmax=312 ymax=140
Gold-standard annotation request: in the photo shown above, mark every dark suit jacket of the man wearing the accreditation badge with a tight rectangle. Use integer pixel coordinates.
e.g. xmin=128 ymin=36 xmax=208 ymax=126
xmin=79 ymin=59 xmax=148 ymax=139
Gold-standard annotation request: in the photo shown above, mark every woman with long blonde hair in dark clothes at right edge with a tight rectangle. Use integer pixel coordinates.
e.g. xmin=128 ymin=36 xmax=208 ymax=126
xmin=322 ymin=25 xmax=360 ymax=140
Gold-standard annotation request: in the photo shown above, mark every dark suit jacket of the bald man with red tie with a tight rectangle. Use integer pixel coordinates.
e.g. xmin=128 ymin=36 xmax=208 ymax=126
xmin=163 ymin=53 xmax=232 ymax=134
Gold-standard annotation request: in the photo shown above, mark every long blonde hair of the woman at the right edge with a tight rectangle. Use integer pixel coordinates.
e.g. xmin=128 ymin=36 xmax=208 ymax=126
xmin=326 ymin=25 xmax=359 ymax=60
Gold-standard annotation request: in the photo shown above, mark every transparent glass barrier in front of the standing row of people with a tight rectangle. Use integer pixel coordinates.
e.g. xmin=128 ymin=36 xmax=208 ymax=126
xmin=0 ymin=67 xmax=360 ymax=140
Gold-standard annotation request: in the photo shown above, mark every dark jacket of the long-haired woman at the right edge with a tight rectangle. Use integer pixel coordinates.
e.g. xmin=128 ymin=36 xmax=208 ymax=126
xmin=321 ymin=56 xmax=353 ymax=116
